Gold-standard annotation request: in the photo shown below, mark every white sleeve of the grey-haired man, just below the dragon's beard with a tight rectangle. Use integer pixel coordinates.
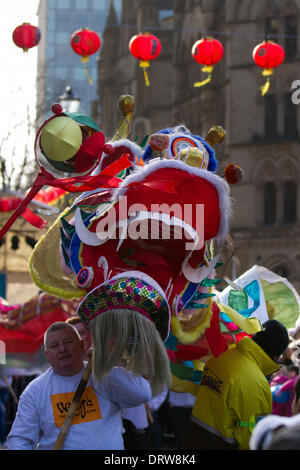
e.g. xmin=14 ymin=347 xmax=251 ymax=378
xmin=94 ymin=367 xmax=151 ymax=408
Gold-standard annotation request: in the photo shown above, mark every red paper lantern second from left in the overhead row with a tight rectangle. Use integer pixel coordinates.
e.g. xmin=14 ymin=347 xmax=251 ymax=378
xmin=70 ymin=28 xmax=101 ymax=85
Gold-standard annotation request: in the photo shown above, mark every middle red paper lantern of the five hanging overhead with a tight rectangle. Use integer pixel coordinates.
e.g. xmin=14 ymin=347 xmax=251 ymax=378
xmin=128 ymin=33 xmax=161 ymax=86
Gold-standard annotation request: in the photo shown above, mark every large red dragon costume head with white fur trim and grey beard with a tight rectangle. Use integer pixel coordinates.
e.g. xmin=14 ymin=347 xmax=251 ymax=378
xmin=30 ymin=96 xmax=296 ymax=394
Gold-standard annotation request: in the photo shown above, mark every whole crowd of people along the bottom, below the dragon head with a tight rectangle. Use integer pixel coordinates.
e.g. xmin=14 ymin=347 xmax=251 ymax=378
xmin=0 ymin=316 xmax=300 ymax=450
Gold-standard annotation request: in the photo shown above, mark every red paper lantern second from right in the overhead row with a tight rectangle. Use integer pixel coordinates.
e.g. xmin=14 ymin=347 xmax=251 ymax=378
xmin=192 ymin=37 xmax=224 ymax=87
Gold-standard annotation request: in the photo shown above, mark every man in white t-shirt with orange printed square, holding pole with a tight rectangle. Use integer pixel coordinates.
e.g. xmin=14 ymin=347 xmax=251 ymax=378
xmin=7 ymin=322 xmax=151 ymax=450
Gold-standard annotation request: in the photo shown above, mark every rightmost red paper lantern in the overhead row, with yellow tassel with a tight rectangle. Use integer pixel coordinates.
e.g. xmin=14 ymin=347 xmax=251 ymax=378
xmin=252 ymin=41 xmax=285 ymax=95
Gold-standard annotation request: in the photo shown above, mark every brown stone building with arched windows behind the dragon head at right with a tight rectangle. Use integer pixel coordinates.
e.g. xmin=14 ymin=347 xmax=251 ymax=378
xmin=96 ymin=0 xmax=300 ymax=290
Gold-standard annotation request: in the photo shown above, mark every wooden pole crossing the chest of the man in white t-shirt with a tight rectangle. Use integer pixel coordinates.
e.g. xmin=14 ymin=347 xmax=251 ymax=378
xmin=53 ymin=358 xmax=93 ymax=450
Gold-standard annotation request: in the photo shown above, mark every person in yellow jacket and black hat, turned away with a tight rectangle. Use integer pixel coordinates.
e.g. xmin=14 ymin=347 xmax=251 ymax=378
xmin=185 ymin=320 xmax=289 ymax=450
